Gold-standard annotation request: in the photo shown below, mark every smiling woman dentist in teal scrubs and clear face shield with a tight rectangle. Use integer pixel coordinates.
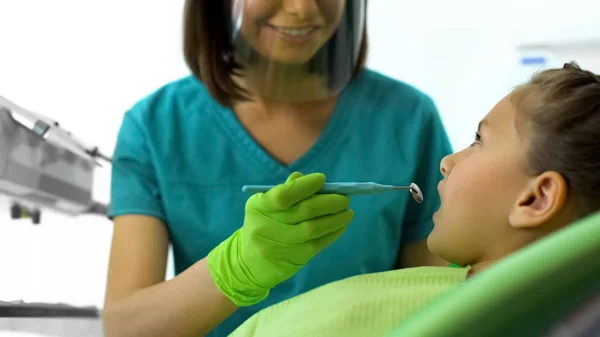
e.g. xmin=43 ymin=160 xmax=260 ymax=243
xmin=103 ymin=0 xmax=451 ymax=337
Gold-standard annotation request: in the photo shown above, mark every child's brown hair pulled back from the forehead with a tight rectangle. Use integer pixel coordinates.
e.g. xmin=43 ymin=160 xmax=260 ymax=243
xmin=513 ymin=62 xmax=600 ymax=216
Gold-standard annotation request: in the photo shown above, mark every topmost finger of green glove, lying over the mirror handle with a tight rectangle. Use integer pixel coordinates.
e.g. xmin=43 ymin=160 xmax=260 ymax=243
xmin=260 ymin=173 xmax=325 ymax=210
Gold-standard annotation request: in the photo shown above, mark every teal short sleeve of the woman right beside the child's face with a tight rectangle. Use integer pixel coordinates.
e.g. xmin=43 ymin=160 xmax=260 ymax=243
xmin=402 ymin=95 xmax=452 ymax=244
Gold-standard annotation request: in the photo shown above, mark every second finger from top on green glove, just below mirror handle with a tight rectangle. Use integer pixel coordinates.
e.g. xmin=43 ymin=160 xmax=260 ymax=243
xmin=270 ymin=194 xmax=350 ymax=225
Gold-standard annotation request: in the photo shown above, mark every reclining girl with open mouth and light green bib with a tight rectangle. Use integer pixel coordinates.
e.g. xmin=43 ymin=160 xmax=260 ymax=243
xmin=226 ymin=64 xmax=600 ymax=337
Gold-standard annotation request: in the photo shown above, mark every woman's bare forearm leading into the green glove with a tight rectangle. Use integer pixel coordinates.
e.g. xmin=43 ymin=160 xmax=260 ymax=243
xmin=103 ymin=259 xmax=238 ymax=337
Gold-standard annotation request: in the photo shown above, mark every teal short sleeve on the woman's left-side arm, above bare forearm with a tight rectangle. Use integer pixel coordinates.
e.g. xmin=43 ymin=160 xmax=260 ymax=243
xmin=108 ymin=107 xmax=166 ymax=221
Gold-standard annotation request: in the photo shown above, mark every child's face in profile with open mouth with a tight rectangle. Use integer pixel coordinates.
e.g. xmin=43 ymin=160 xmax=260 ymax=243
xmin=428 ymin=96 xmax=531 ymax=265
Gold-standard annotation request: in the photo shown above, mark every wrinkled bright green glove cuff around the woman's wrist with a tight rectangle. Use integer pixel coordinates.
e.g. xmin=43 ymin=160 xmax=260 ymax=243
xmin=208 ymin=230 xmax=270 ymax=307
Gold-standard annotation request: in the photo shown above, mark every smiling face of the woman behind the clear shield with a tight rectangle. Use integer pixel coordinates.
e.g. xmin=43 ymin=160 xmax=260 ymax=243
xmin=233 ymin=0 xmax=346 ymax=64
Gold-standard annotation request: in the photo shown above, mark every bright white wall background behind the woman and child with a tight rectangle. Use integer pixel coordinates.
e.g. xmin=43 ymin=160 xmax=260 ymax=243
xmin=0 ymin=0 xmax=600 ymax=306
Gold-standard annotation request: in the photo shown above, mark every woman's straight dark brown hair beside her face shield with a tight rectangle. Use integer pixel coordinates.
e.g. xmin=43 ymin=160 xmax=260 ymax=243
xmin=183 ymin=0 xmax=367 ymax=106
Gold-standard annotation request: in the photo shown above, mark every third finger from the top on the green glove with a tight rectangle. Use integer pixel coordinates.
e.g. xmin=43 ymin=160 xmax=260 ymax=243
xmin=273 ymin=209 xmax=354 ymax=245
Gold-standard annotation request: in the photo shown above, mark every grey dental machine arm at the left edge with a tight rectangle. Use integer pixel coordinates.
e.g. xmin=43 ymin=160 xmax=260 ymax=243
xmin=0 ymin=96 xmax=112 ymax=224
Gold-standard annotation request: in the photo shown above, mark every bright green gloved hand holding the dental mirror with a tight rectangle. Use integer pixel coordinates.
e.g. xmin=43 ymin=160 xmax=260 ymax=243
xmin=208 ymin=172 xmax=354 ymax=306
